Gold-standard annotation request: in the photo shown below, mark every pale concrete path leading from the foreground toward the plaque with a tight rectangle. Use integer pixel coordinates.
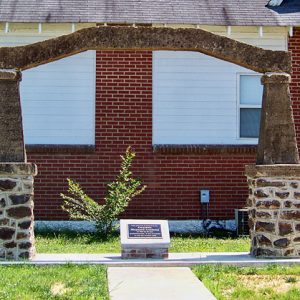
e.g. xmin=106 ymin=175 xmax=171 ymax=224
xmin=108 ymin=267 xmax=216 ymax=300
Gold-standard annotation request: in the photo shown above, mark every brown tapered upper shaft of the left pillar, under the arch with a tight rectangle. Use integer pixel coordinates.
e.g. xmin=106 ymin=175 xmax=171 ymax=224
xmin=0 ymin=70 xmax=26 ymax=162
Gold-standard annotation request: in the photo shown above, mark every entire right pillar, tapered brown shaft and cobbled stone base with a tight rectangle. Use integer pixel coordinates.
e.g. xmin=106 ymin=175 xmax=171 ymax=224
xmin=246 ymin=73 xmax=300 ymax=257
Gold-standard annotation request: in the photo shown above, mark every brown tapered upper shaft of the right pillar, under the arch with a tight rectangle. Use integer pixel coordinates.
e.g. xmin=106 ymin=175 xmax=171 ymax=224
xmin=256 ymin=73 xmax=299 ymax=165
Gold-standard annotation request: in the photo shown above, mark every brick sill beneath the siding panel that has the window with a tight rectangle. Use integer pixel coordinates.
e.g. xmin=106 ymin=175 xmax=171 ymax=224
xmin=152 ymin=145 xmax=257 ymax=155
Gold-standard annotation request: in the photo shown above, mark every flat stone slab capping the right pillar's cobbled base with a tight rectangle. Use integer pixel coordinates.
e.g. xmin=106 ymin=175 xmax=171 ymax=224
xmin=245 ymin=164 xmax=300 ymax=178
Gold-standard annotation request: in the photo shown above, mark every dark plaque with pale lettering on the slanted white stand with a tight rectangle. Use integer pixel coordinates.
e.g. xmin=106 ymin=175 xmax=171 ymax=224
xmin=128 ymin=224 xmax=162 ymax=239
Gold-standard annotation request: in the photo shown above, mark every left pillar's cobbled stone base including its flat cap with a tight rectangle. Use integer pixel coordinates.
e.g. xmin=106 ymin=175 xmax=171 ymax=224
xmin=0 ymin=163 xmax=37 ymax=260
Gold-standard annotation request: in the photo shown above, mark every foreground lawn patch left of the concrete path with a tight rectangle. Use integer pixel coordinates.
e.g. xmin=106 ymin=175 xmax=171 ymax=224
xmin=0 ymin=265 xmax=109 ymax=300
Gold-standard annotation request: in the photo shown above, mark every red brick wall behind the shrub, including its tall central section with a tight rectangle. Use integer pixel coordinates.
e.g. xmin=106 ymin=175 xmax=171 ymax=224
xmin=28 ymin=51 xmax=256 ymax=220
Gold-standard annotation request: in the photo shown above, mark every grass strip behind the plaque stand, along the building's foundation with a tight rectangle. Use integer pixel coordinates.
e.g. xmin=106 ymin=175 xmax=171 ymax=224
xmin=36 ymin=232 xmax=250 ymax=253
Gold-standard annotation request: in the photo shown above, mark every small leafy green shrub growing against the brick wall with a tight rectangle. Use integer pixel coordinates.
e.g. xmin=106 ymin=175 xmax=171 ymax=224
xmin=61 ymin=147 xmax=146 ymax=236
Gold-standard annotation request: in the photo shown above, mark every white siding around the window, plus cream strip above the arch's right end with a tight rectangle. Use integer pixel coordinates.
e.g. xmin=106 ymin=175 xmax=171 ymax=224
xmin=153 ymin=27 xmax=287 ymax=144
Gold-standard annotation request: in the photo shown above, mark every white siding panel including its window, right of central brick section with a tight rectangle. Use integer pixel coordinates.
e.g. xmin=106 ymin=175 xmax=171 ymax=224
xmin=152 ymin=51 xmax=263 ymax=145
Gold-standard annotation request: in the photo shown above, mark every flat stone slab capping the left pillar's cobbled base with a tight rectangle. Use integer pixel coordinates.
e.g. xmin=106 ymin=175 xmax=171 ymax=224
xmin=0 ymin=163 xmax=37 ymax=176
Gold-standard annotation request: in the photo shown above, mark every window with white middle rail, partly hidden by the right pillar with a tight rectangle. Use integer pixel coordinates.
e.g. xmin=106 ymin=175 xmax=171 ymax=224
xmin=239 ymin=74 xmax=263 ymax=138
